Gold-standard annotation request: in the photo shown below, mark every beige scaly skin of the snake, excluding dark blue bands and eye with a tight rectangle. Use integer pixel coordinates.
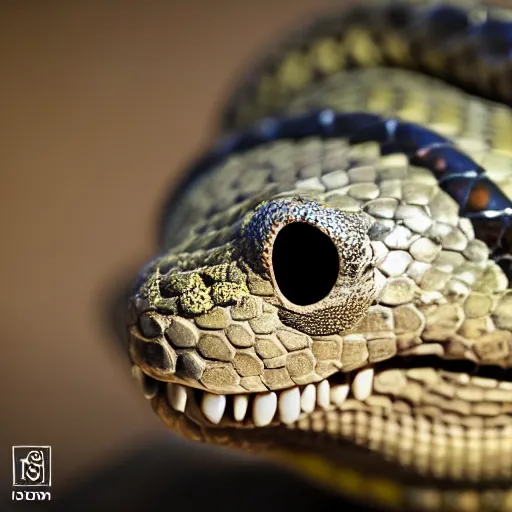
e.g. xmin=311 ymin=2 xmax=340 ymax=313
xmin=128 ymin=1 xmax=512 ymax=511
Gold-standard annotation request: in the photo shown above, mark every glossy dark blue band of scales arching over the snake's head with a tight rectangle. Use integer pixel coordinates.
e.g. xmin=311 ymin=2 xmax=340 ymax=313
xmin=165 ymin=109 xmax=512 ymax=282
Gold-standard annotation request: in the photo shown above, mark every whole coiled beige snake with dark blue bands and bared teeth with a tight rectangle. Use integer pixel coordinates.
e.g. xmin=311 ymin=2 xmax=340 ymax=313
xmin=125 ymin=1 xmax=512 ymax=511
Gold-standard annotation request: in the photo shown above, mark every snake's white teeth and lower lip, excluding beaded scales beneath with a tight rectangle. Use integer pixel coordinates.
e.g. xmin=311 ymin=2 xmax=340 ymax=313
xmin=161 ymin=356 xmax=512 ymax=431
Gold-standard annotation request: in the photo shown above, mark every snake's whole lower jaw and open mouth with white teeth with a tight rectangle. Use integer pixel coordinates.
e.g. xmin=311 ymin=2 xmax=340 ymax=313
xmin=137 ymin=356 xmax=512 ymax=486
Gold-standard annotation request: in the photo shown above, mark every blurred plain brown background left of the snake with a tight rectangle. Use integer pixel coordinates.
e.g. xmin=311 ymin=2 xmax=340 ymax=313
xmin=0 ymin=0 xmax=348 ymax=506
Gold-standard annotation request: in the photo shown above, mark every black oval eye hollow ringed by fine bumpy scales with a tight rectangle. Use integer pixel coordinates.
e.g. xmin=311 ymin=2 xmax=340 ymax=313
xmin=272 ymin=222 xmax=340 ymax=306
